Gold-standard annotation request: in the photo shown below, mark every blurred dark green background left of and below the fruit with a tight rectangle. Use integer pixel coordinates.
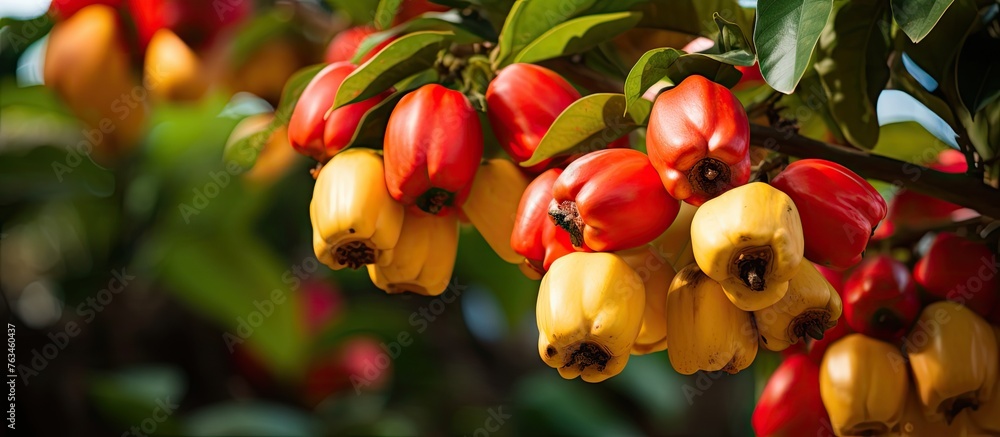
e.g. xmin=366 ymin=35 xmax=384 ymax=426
xmin=0 ymin=2 xmax=764 ymax=436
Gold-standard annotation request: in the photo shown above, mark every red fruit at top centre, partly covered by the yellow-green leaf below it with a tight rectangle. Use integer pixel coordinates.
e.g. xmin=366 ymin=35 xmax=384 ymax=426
xmin=486 ymin=64 xmax=628 ymax=174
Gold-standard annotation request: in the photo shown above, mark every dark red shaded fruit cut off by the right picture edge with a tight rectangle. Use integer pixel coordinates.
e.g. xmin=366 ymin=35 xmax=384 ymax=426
xmin=913 ymin=232 xmax=1000 ymax=317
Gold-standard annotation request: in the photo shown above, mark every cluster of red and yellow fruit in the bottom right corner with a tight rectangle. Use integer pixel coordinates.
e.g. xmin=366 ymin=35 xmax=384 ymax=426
xmin=754 ymin=227 xmax=1000 ymax=436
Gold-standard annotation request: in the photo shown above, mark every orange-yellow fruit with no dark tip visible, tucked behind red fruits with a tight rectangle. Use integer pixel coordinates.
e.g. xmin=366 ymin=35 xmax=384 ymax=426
xmin=462 ymin=159 xmax=528 ymax=264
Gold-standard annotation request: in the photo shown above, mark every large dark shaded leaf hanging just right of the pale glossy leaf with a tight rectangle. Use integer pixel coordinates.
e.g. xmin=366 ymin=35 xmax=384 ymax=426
xmin=815 ymin=0 xmax=890 ymax=149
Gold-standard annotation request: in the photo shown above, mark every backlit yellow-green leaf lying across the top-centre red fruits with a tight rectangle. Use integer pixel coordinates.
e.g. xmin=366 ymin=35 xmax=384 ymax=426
xmin=521 ymin=93 xmax=652 ymax=167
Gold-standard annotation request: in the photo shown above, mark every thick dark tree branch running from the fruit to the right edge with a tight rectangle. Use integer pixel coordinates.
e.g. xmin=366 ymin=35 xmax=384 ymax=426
xmin=750 ymin=123 xmax=1000 ymax=218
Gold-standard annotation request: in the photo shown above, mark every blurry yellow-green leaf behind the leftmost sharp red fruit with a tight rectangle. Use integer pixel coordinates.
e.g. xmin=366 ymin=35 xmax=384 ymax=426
xmin=222 ymin=64 xmax=326 ymax=170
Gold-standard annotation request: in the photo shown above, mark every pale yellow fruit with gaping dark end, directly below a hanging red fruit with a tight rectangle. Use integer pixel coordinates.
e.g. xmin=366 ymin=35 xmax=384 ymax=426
xmin=691 ymin=182 xmax=804 ymax=311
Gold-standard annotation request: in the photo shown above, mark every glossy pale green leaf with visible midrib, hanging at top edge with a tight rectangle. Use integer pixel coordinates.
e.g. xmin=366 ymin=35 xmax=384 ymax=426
xmin=753 ymin=0 xmax=833 ymax=94
